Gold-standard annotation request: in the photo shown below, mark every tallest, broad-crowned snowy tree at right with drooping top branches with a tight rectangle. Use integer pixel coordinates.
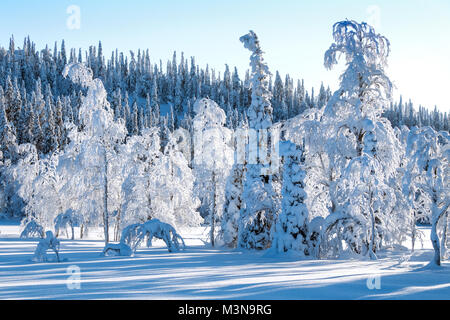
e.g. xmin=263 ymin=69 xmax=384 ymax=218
xmin=316 ymin=20 xmax=401 ymax=258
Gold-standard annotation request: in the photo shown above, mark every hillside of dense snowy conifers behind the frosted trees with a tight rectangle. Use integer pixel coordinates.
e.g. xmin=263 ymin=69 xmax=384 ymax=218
xmin=0 ymin=38 xmax=450 ymax=158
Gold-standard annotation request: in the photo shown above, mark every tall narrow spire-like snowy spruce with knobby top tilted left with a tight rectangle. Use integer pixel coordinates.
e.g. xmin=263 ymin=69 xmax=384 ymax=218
xmin=238 ymin=31 xmax=279 ymax=249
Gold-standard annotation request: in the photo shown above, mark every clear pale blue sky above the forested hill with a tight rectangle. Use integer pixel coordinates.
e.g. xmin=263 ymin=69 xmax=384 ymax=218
xmin=0 ymin=0 xmax=450 ymax=112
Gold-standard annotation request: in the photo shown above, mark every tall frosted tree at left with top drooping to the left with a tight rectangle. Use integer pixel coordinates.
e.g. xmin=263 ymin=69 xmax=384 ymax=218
xmin=63 ymin=63 xmax=126 ymax=243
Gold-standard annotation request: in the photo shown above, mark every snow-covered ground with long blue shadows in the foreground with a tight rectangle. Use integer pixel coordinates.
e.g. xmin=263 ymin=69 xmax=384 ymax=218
xmin=0 ymin=222 xmax=450 ymax=299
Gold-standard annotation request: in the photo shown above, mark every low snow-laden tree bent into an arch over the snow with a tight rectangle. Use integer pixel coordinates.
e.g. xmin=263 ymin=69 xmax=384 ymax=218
xmin=103 ymin=219 xmax=186 ymax=256
